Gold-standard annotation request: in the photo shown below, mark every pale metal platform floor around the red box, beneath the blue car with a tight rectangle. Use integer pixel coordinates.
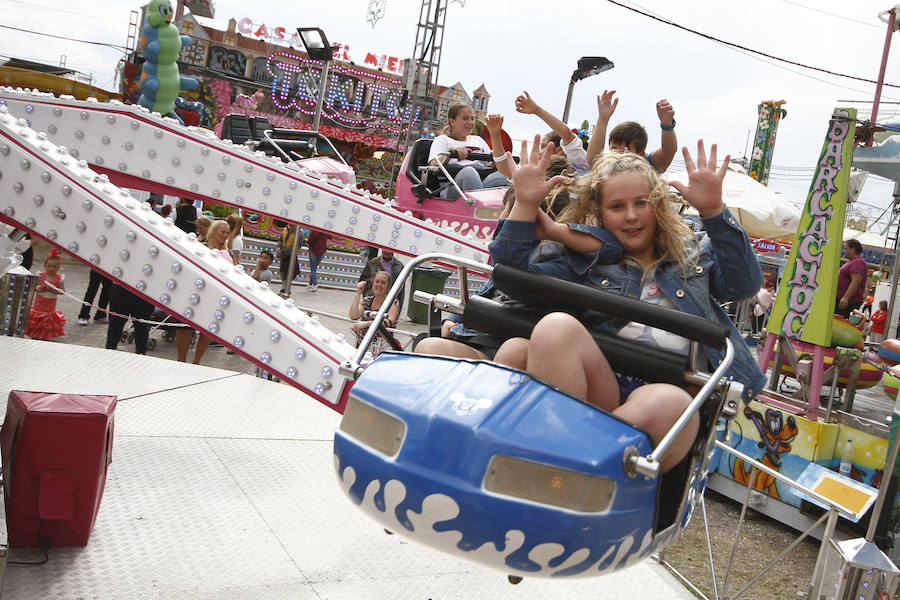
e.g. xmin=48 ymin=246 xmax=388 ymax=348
xmin=0 ymin=337 xmax=694 ymax=600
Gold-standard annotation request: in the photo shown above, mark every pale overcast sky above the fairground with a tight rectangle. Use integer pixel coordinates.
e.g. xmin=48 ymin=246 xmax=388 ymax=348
xmin=0 ymin=0 xmax=900 ymax=233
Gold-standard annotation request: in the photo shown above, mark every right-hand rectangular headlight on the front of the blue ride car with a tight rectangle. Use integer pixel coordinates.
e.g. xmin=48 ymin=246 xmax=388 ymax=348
xmin=484 ymin=454 xmax=616 ymax=513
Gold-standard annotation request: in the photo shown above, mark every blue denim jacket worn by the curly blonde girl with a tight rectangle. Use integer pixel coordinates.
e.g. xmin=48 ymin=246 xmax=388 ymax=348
xmin=490 ymin=208 xmax=766 ymax=402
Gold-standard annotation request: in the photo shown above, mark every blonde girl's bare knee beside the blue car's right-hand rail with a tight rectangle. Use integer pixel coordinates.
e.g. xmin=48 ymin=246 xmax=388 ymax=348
xmin=612 ymin=383 xmax=700 ymax=472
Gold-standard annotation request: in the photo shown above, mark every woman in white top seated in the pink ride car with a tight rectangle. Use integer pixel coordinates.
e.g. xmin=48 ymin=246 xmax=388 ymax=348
xmin=428 ymin=103 xmax=510 ymax=200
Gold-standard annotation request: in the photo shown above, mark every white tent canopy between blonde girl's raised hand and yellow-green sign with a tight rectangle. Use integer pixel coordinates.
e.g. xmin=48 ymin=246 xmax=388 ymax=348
xmin=666 ymin=169 xmax=800 ymax=238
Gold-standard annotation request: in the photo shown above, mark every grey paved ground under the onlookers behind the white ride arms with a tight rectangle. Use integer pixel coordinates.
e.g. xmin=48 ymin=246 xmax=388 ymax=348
xmin=32 ymin=242 xmax=426 ymax=374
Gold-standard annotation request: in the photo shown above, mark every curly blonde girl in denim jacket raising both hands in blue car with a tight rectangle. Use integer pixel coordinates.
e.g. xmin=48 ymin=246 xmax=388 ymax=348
xmin=491 ymin=140 xmax=765 ymax=470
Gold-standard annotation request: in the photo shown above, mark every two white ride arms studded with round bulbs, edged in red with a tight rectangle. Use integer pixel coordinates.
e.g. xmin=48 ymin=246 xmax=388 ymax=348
xmin=0 ymin=88 xmax=489 ymax=412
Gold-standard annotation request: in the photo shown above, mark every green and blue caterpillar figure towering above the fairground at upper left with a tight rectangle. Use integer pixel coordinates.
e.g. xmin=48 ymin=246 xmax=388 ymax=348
xmin=138 ymin=0 xmax=200 ymax=124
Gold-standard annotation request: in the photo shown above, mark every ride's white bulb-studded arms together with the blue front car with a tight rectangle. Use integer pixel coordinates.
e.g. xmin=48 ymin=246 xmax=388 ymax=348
xmin=0 ymin=78 xmax=739 ymax=576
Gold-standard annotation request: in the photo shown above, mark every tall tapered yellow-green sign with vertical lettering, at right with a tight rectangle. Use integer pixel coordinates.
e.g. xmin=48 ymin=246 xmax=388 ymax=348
xmin=769 ymin=108 xmax=856 ymax=346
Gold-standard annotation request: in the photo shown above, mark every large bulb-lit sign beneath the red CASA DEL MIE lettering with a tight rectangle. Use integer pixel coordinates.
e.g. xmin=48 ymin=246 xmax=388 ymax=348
xmin=266 ymin=52 xmax=421 ymax=133
